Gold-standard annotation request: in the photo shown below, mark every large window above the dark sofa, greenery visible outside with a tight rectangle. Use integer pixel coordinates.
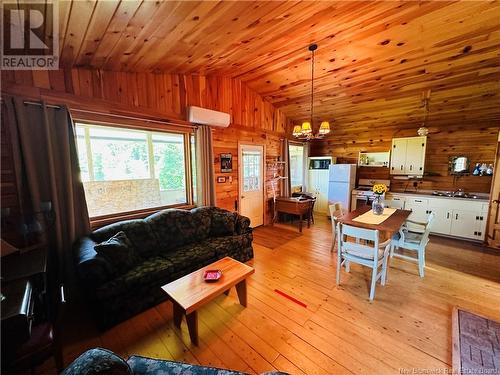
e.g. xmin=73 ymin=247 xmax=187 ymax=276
xmin=76 ymin=123 xmax=195 ymax=217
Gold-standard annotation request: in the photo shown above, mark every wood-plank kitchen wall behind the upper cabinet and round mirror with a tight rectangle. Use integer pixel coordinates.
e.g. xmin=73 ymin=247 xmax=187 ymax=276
xmin=311 ymin=123 xmax=499 ymax=193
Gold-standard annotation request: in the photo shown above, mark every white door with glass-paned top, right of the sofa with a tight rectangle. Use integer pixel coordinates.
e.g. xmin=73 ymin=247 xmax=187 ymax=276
xmin=239 ymin=145 xmax=265 ymax=228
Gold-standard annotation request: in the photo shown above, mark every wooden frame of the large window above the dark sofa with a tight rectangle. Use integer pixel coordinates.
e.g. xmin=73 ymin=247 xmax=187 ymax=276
xmin=73 ymin=117 xmax=196 ymax=229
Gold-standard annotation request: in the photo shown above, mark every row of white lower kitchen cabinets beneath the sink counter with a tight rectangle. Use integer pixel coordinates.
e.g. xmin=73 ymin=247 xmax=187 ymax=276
xmin=385 ymin=193 xmax=488 ymax=241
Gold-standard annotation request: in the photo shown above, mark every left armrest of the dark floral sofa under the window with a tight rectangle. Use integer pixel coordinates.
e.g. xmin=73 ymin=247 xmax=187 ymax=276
xmin=74 ymin=237 xmax=114 ymax=289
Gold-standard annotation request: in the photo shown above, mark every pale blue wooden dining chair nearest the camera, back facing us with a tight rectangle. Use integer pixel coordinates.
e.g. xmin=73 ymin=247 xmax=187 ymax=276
xmin=337 ymin=223 xmax=391 ymax=301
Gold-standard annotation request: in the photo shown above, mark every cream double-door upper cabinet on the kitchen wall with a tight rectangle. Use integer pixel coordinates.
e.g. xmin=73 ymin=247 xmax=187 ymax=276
xmin=391 ymin=137 xmax=427 ymax=176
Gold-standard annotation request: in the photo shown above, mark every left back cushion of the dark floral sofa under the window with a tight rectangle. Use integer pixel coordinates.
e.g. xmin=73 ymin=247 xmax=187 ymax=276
xmin=90 ymin=219 xmax=158 ymax=258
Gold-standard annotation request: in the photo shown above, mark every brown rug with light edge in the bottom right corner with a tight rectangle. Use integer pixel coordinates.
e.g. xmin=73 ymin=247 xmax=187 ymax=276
xmin=452 ymin=309 xmax=500 ymax=374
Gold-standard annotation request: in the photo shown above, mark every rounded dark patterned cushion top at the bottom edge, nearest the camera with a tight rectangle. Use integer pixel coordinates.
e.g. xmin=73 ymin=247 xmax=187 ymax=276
xmin=61 ymin=348 xmax=133 ymax=375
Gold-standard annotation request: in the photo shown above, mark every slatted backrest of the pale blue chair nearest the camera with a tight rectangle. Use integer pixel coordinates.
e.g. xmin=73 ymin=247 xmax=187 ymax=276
xmin=337 ymin=223 xmax=379 ymax=260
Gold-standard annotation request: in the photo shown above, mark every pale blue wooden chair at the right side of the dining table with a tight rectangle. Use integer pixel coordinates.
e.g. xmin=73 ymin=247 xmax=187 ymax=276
xmin=391 ymin=212 xmax=434 ymax=277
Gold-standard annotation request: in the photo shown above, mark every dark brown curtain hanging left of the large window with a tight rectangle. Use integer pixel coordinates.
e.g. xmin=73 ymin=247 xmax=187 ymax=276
xmin=3 ymin=96 xmax=90 ymax=292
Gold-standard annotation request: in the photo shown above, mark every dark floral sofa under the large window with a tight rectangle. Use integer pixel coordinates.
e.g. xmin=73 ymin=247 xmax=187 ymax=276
xmin=74 ymin=207 xmax=253 ymax=328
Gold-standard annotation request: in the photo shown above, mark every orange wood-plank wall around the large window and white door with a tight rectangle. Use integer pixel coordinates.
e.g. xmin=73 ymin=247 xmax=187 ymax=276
xmin=2 ymin=69 xmax=287 ymax=222
